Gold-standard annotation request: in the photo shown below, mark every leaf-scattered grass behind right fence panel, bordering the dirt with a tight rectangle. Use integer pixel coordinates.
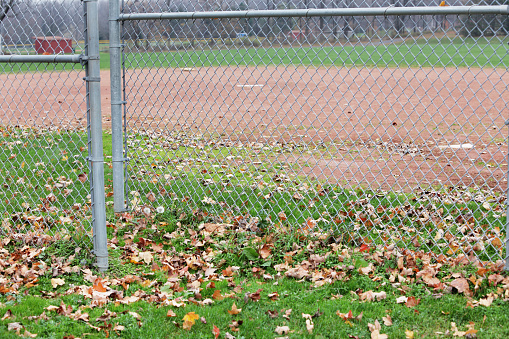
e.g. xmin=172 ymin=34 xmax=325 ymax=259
xmin=123 ymin=130 xmax=506 ymax=260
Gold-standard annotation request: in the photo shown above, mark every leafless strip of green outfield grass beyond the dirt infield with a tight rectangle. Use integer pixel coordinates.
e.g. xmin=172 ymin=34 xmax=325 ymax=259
xmin=0 ymin=37 xmax=509 ymax=73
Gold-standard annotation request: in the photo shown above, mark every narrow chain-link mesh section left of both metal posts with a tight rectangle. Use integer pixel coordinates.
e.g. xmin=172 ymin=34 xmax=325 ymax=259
xmin=0 ymin=0 xmax=92 ymax=249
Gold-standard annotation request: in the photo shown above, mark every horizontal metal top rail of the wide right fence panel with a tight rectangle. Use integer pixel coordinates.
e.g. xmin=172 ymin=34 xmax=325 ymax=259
xmin=118 ymin=5 xmax=509 ymax=21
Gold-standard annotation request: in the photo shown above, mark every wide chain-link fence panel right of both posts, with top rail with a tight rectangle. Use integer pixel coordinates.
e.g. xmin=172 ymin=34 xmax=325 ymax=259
xmin=120 ymin=2 xmax=509 ymax=261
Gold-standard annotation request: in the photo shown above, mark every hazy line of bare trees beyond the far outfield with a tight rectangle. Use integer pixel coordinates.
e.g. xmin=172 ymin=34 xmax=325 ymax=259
xmin=0 ymin=0 xmax=509 ymax=50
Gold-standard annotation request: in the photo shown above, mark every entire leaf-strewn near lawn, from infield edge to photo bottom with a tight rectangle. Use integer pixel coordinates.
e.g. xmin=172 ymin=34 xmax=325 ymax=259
xmin=0 ymin=129 xmax=509 ymax=338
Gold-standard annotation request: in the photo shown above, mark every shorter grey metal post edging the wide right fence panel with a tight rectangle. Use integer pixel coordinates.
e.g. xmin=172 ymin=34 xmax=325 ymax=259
xmin=109 ymin=0 xmax=125 ymax=212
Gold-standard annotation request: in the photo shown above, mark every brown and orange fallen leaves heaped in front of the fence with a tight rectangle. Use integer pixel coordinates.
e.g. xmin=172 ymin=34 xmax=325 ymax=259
xmin=0 ymin=207 xmax=509 ymax=338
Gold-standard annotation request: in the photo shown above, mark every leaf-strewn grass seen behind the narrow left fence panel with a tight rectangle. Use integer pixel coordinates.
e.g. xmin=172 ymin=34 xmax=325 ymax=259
xmin=0 ymin=127 xmax=111 ymax=247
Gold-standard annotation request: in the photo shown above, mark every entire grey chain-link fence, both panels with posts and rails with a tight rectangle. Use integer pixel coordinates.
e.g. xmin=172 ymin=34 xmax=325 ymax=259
xmin=0 ymin=0 xmax=509 ymax=269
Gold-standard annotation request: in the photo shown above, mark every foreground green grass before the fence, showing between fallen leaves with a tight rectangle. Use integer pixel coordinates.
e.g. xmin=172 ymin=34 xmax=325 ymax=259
xmin=0 ymin=210 xmax=509 ymax=338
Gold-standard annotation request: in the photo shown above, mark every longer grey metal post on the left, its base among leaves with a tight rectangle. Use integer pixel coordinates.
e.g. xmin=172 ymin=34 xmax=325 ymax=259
xmin=85 ymin=0 xmax=108 ymax=271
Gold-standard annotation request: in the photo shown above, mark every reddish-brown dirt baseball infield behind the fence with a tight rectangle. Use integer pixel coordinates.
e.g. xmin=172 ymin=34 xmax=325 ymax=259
xmin=0 ymin=67 xmax=509 ymax=190
